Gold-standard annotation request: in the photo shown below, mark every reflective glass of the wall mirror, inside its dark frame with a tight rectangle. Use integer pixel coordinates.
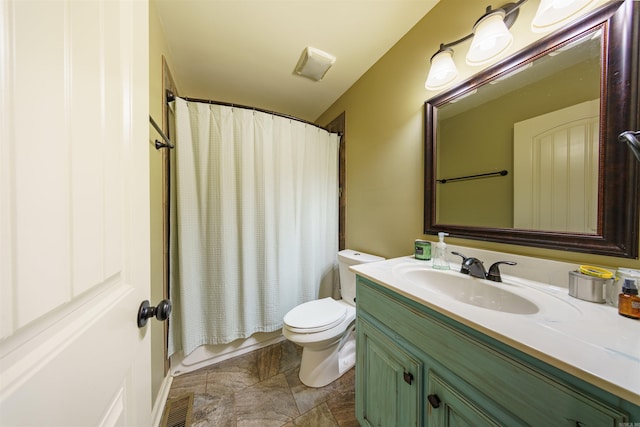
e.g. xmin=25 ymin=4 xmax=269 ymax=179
xmin=436 ymin=30 xmax=602 ymax=233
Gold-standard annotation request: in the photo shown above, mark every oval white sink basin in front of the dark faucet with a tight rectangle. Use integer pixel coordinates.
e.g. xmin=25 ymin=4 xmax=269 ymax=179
xmin=395 ymin=265 xmax=540 ymax=314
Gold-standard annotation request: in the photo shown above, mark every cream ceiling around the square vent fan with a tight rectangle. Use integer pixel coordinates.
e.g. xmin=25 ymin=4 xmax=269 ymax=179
xmin=152 ymin=0 xmax=438 ymax=121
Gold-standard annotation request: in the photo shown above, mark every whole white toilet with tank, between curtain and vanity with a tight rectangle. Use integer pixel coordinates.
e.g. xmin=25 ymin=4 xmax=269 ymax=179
xmin=282 ymin=249 xmax=384 ymax=387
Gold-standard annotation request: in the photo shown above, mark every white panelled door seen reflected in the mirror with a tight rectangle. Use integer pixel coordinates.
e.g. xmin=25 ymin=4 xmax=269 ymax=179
xmin=513 ymin=99 xmax=600 ymax=234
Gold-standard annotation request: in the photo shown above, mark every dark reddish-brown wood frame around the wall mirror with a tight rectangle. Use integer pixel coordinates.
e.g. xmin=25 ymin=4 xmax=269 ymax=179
xmin=424 ymin=0 xmax=640 ymax=258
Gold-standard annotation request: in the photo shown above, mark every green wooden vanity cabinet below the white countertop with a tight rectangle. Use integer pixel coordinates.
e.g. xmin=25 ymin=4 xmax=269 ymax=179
xmin=356 ymin=276 xmax=640 ymax=427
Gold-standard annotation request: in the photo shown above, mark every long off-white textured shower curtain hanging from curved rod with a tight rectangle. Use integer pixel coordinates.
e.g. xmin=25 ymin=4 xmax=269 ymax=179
xmin=169 ymin=98 xmax=339 ymax=355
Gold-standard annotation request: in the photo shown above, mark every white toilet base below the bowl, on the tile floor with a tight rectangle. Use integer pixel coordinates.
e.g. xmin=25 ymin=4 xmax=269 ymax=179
xmin=299 ymin=331 xmax=356 ymax=388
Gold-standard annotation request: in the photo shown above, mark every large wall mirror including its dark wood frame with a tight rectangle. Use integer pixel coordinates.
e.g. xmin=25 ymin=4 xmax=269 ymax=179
xmin=424 ymin=1 xmax=640 ymax=258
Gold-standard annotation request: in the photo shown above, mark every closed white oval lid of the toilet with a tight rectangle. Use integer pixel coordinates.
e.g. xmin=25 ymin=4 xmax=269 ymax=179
xmin=284 ymin=298 xmax=347 ymax=333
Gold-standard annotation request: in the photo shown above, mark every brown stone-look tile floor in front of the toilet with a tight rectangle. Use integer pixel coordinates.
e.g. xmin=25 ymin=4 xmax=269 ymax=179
xmin=168 ymin=341 xmax=359 ymax=427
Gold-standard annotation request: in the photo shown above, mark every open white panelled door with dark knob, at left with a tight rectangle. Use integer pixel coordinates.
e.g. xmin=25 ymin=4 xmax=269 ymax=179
xmin=0 ymin=0 xmax=151 ymax=427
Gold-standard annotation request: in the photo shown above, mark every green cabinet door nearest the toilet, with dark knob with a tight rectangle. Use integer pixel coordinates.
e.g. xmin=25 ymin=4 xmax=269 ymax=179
xmin=356 ymin=318 xmax=422 ymax=427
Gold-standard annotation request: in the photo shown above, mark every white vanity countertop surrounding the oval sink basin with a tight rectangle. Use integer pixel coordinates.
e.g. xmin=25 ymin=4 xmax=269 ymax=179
xmin=351 ymin=256 xmax=640 ymax=405
